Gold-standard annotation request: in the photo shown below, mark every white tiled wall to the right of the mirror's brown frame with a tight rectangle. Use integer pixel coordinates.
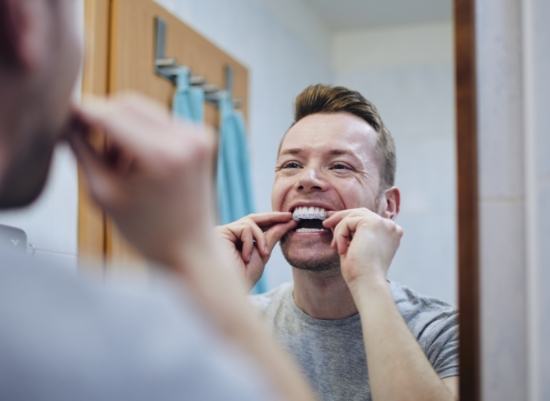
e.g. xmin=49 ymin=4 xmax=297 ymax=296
xmin=476 ymin=0 xmax=550 ymax=401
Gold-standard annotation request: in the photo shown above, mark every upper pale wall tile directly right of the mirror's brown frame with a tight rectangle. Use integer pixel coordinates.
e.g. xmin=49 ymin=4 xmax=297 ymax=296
xmin=476 ymin=0 xmax=524 ymax=198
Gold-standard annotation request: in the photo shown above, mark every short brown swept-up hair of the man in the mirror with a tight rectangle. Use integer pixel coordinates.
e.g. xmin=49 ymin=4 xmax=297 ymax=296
xmin=292 ymin=84 xmax=396 ymax=187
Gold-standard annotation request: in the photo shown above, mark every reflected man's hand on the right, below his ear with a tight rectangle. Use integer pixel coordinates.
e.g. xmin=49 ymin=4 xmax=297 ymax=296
xmin=323 ymin=208 xmax=403 ymax=290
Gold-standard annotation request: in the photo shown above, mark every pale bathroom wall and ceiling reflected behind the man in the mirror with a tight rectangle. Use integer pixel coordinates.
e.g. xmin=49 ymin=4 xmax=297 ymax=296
xmin=158 ymin=0 xmax=457 ymax=305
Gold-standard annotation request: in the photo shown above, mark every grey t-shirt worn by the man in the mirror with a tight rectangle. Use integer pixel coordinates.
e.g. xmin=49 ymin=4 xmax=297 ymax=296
xmin=253 ymin=282 xmax=458 ymax=401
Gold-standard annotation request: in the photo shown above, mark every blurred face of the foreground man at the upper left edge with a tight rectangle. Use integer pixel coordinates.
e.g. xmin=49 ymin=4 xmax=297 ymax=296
xmin=0 ymin=0 xmax=81 ymax=208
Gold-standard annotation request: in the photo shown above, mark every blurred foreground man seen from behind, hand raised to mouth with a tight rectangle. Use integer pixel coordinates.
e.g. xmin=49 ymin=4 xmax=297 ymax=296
xmin=0 ymin=0 xmax=320 ymax=401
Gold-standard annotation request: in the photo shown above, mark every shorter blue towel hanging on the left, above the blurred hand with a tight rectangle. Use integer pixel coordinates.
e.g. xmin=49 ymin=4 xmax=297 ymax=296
xmin=172 ymin=67 xmax=204 ymax=123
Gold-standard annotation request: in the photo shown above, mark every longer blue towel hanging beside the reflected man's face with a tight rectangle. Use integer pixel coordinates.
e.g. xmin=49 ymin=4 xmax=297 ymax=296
xmin=216 ymin=92 xmax=266 ymax=293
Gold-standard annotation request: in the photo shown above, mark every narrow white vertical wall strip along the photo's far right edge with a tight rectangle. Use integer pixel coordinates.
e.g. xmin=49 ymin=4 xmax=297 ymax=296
xmin=523 ymin=0 xmax=550 ymax=401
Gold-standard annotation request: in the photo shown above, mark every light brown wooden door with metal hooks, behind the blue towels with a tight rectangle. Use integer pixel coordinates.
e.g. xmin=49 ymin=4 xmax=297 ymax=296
xmin=79 ymin=0 xmax=248 ymax=270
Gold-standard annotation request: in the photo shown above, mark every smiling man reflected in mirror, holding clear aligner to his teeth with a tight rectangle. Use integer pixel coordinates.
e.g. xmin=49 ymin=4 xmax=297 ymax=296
xmin=217 ymin=85 xmax=458 ymax=401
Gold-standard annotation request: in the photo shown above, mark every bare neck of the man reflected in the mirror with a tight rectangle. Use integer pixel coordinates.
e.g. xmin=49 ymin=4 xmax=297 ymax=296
xmin=292 ymin=268 xmax=357 ymax=320
